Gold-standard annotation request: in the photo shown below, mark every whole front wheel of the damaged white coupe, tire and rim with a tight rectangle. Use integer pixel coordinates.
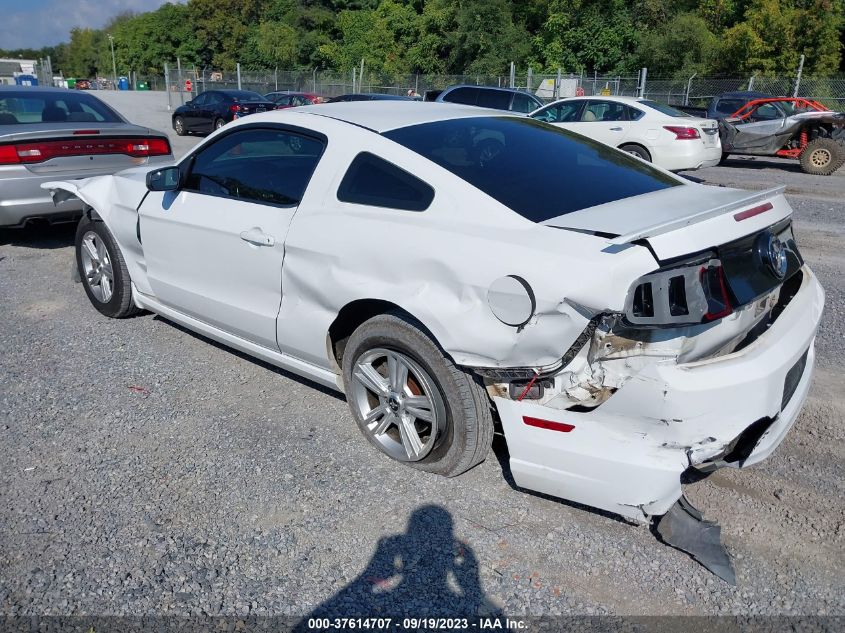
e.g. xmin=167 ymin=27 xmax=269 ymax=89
xmin=76 ymin=216 xmax=140 ymax=319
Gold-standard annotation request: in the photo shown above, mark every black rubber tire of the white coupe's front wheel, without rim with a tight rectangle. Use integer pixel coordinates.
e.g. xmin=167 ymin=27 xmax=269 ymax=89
xmin=75 ymin=214 xmax=141 ymax=319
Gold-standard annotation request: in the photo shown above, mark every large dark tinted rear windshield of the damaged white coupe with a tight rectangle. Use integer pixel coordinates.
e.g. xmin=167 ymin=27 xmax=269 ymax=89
xmin=384 ymin=117 xmax=681 ymax=222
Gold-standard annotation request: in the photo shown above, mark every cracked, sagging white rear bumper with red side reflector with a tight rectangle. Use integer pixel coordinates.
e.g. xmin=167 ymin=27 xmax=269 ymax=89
xmin=494 ymin=267 xmax=824 ymax=522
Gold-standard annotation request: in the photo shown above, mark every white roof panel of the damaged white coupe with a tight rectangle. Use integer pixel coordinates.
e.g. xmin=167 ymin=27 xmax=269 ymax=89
xmin=262 ymin=101 xmax=522 ymax=133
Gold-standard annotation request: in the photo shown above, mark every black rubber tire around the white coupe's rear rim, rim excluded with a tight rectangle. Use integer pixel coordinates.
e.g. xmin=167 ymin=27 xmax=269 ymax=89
xmin=343 ymin=313 xmax=493 ymax=477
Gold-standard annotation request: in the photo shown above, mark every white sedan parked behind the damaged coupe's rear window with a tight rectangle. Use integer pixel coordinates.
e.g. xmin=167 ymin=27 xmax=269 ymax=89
xmin=531 ymin=97 xmax=722 ymax=171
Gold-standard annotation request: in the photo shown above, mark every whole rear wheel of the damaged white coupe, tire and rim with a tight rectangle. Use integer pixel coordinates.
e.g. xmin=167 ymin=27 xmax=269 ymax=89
xmin=343 ymin=313 xmax=493 ymax=477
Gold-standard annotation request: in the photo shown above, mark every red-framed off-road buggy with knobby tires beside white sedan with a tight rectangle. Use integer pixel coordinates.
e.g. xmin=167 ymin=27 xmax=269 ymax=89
xmin=719 ymin=97 xmax=845 ymax=176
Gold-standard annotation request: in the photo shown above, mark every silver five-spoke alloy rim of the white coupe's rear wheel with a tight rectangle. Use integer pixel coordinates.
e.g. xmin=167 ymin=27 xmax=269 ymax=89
xmin=350 ymin=348 xmax=446 ymax=462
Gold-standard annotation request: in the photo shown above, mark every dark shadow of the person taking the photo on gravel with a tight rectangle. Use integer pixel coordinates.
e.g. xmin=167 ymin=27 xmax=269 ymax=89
xmin=293 ymin=505 xmax=504 ymax=631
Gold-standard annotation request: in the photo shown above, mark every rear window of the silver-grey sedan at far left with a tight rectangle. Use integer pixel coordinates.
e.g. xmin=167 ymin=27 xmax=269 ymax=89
xmin=0 ymin=90 xmax=122 ymax=125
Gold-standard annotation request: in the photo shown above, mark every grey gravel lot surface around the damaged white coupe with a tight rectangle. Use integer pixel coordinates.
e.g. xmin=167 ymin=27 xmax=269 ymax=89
xmin=0 ymin=93 xmax=845 ymax=616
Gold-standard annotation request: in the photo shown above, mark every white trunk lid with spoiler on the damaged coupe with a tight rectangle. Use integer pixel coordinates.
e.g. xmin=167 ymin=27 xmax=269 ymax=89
xmin=543 ymin=183 xmax=792 ymax=262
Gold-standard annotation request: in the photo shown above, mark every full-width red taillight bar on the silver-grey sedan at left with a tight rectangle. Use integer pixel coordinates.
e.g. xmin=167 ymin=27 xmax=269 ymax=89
xmin=0 ymin=138 xmax=170 ymax=165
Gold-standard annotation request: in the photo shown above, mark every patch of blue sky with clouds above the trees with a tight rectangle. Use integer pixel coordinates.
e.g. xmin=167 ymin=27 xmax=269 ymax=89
xmin=0 ymin=0 xmax=184 ymax=49
